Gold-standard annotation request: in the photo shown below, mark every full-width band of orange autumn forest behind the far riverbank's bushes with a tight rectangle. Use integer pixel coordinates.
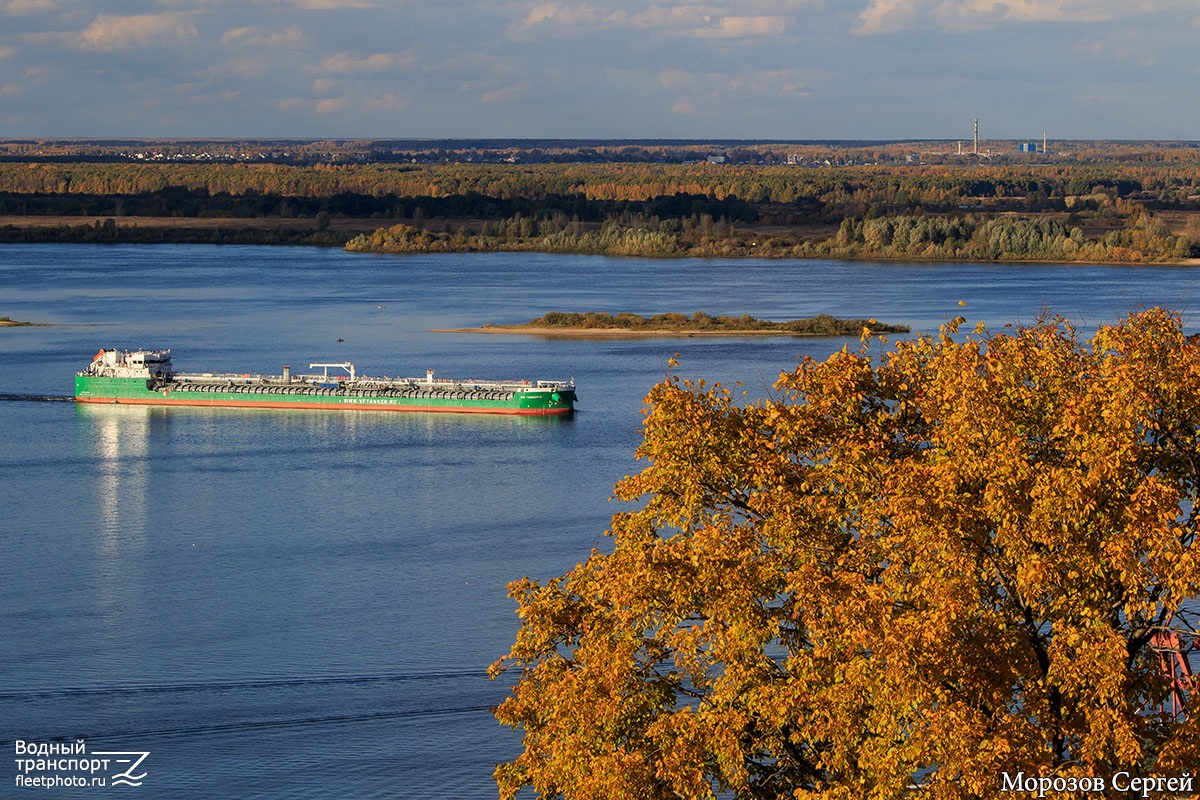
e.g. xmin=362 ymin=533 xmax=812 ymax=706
xmin=7 ymin=159 xmax=1200 ymax=222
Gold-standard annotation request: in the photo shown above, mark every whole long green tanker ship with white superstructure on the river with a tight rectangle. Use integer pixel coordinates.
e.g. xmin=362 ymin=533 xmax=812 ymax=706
xmin=74 ymin=350 xmax=575 ymax=416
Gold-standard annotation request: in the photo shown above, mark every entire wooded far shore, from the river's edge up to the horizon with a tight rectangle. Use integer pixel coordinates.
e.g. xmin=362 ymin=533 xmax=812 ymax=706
xmin=0 ymin=143 xmax=1200 ymax=261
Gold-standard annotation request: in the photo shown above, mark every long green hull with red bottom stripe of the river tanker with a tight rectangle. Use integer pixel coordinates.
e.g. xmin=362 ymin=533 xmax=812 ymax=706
xmin=74 ymin=375 xmax=575 ymax=416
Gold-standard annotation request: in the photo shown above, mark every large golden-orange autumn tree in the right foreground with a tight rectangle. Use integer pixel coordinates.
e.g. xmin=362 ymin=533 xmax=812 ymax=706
xmin=493 ymin=309 xmax=1200 ymax=800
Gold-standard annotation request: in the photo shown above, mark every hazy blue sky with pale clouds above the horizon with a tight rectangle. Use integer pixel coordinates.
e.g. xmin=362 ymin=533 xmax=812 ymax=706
xmin=0 ymin=0 xmax=1200 ymax=139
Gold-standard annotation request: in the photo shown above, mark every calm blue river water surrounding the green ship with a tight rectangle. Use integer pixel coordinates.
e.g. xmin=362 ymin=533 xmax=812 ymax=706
xmin=0 ymin=245 xmax=1200 ymax=799
